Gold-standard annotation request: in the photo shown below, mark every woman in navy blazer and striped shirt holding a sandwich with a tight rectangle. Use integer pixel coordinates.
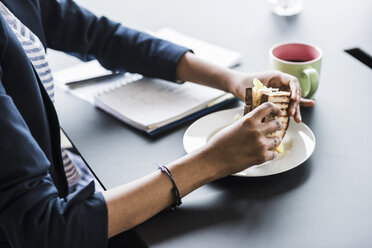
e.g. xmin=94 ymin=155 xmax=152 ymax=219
xmin=0 ymin=0 xmax=313 ymax=248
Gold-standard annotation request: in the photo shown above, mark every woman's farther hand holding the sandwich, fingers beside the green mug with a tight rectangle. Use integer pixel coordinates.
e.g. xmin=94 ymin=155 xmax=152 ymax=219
xmin=228 ymin=71 xmax=315 ymax=122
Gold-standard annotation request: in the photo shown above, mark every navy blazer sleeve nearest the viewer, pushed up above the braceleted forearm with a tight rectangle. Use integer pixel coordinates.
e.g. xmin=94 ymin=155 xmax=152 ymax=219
xmin=0 ymin=67 xmax=107 ymax=248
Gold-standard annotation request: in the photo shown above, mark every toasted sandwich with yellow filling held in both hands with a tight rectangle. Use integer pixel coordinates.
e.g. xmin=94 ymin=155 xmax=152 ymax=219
xmin=244 ymin=79 xmax=291 ymax=153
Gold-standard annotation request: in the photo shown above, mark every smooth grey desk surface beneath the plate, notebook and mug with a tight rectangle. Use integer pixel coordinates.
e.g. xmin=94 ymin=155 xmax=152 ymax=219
xmin=52 ymin=0 xmax=372 ymax=247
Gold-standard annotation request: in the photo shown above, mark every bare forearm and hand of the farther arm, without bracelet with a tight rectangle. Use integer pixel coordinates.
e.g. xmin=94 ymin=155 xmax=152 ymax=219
xmin=176 ymin=53 xmax=315 ymax=122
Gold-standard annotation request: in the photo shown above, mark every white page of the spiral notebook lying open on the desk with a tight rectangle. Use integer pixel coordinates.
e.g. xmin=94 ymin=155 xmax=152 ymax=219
xmin=95 ymin=78 xmax=226 ymax=130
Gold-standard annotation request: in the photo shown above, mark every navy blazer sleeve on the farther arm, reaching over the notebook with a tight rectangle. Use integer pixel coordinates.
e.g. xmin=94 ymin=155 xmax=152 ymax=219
xmin=40 ymin=0 xmax=189 ymax=81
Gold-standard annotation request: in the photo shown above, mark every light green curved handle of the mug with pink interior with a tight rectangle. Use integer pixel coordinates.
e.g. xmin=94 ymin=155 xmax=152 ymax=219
xmin=300 ymin=67 xmax=319 ymax=99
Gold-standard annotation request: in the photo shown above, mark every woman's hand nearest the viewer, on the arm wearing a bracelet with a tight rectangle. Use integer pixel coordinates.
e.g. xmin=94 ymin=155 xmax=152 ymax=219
xmin=201 ymin=103 xmax=282 ymax=177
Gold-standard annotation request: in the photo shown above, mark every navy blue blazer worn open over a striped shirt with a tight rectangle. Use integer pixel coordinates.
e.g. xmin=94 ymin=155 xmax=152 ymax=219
xmin=0 ymin=0 xmax=187 ymax=248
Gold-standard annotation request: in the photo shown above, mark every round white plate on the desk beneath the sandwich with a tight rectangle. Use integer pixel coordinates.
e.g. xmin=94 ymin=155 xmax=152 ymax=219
xmin=183 ymin=108 xmax=315 ymax=177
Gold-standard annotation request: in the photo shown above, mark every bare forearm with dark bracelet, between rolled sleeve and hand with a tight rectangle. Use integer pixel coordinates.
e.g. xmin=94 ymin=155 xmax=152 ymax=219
xmin=104 ymin=148 xmax=217 ymax=237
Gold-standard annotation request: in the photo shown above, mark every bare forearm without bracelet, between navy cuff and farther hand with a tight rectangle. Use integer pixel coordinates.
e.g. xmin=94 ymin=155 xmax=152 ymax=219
xmin=176 ymin=53 xmax=247 ymax=94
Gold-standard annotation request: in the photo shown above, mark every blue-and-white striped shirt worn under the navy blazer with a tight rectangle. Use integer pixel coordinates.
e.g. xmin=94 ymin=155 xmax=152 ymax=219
xmin=0 ymin=2 xmax=99 ymax=192
